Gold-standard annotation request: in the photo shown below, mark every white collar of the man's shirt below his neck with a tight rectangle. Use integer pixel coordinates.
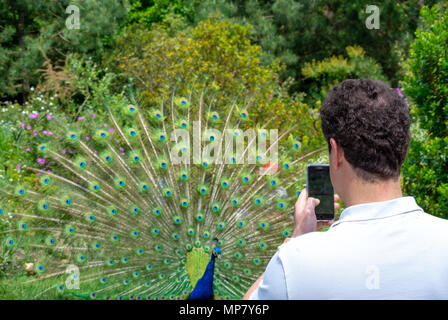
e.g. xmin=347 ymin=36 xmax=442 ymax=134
xmin=331 ymin=197 xmax=423 ymax=228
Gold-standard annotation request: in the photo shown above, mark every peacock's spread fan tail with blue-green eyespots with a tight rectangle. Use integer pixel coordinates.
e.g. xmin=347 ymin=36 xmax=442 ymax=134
xmin=0 ymin=88 xmax=317 ymax=299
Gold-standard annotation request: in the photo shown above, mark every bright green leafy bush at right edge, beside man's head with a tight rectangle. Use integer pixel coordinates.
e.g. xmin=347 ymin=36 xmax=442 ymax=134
xmin=403 ymin=6 xmax=448 ymax=218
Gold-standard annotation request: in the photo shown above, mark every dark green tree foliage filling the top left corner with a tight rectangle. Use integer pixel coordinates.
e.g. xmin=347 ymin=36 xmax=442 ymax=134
xmin=0 ymin=0 xmax=127 ymax=102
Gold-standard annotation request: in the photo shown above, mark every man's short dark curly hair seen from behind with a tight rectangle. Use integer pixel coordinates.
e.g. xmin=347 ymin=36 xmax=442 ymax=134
xmin=320 ymin=79 xmax=411 ymax=182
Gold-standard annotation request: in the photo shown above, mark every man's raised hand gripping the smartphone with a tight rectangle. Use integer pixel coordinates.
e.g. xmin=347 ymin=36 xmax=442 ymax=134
xmin=292 ymin=188 xmax=339 ymax=237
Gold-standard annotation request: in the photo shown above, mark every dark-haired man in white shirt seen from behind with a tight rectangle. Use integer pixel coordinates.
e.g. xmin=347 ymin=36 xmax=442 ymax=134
xmin=244 ymin=79 xmax=448 ymax=299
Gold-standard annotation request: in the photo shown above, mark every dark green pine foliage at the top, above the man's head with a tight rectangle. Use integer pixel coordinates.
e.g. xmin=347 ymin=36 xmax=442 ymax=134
xmin=186 ymin=0 xmax=435 ymax=92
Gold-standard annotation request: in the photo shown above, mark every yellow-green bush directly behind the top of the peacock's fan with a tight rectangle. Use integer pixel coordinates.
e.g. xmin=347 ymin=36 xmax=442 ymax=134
xmin=107 ymin=15 xmax=323 ymax=146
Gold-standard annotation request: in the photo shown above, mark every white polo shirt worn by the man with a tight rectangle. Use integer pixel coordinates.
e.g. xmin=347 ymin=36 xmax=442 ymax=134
xmin=251 ymin=197 xmax=448 ymax=299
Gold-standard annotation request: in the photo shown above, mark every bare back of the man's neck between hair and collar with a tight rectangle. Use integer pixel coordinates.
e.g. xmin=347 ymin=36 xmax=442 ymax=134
xmin=343 ymin=179 xmax=403 ymax=207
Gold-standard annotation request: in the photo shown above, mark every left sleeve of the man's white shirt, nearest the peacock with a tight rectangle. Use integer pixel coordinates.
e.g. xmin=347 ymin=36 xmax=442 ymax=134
xmin=250 ymin=251 xmax=288 ymax=300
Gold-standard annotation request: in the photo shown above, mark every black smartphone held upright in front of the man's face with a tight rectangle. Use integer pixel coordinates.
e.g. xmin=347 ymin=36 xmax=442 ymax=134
xmin=306 ymin=164 xmax=334 ymax=220
